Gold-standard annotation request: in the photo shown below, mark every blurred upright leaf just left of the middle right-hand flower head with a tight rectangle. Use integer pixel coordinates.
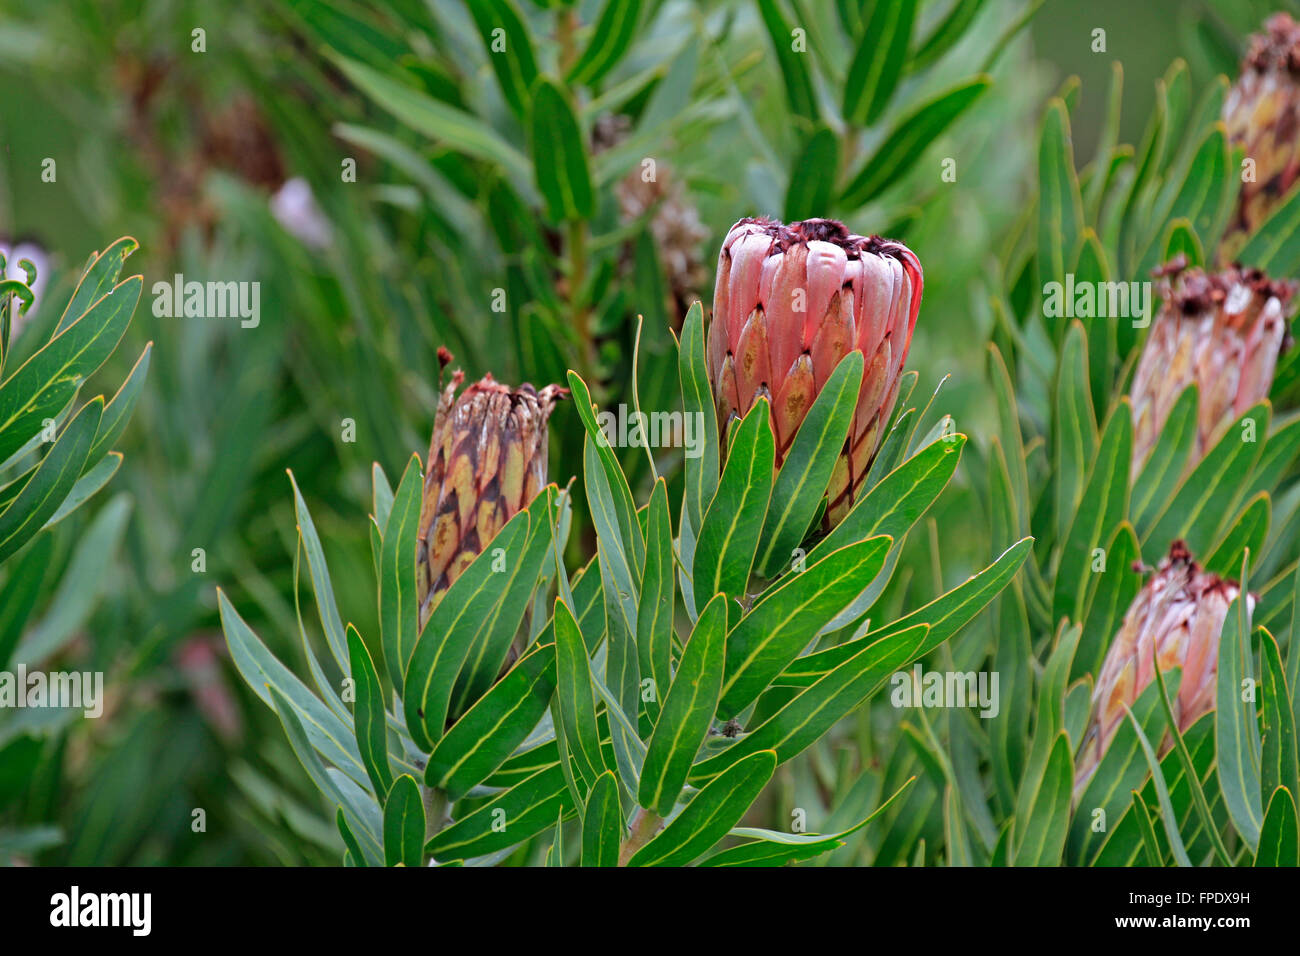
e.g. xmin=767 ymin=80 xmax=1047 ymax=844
xmin=1052 ymin=399 xmax=1134 ymax=620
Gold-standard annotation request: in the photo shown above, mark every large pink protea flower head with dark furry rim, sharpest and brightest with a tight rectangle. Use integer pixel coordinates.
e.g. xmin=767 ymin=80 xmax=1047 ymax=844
xmin=709 ymin=219 xmax=923 ymax=527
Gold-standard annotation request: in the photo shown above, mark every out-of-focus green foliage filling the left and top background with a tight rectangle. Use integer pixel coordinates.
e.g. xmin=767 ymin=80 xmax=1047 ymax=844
xmin=0 ymin=0 xmax=1274 ymax=864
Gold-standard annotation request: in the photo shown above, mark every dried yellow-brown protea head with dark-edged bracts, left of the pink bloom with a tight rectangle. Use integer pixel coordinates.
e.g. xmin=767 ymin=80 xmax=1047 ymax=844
xmin=416 ymin=349 xmax=568 ymax=630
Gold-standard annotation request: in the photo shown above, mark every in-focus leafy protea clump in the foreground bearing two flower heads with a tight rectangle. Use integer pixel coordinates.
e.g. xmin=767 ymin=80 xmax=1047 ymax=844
xmin=221 ymin=214 xmax=1030 ymax=866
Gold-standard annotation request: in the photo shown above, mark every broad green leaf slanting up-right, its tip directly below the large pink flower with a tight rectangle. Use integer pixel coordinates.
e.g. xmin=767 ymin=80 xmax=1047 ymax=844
xmin=718 ymin=536 xmax=892 ymax=717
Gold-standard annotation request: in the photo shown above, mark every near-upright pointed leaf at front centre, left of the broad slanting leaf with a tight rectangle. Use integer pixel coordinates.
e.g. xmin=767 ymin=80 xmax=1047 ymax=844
xmin=637 ymin=594 xmax=727 ymax=817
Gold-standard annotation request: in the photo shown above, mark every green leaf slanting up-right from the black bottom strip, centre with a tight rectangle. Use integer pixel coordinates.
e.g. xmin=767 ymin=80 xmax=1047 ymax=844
xmin=628 ymin=750 xmax=776 ymax=866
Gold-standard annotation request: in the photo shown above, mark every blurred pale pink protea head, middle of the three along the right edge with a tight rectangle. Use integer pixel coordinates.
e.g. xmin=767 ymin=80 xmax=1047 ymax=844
xmin=1131 ymin=256 xmax=1296 ymax=476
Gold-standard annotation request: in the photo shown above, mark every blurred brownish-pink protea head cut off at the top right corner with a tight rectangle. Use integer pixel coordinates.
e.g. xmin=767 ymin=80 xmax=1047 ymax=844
xmin=1221 ymin=13 xmax=1300 ymax=261
